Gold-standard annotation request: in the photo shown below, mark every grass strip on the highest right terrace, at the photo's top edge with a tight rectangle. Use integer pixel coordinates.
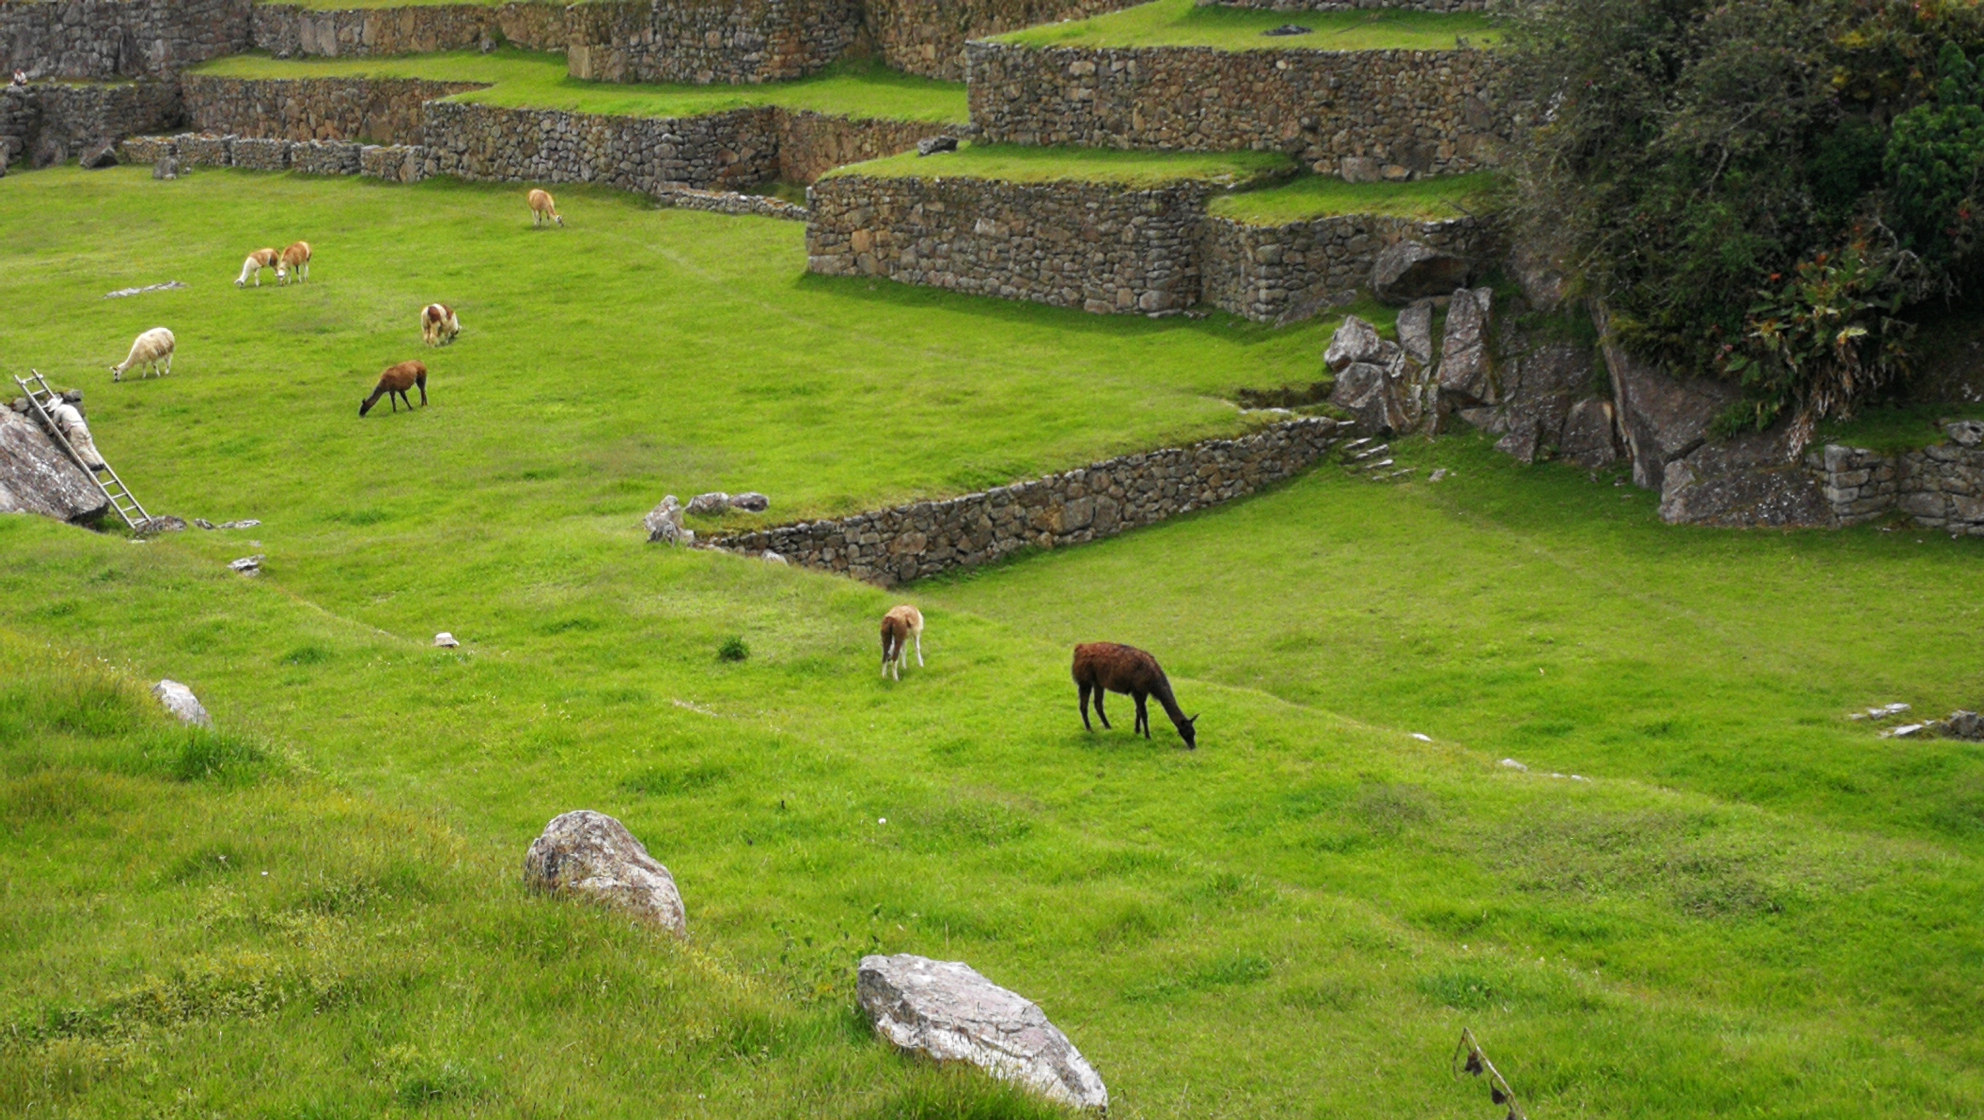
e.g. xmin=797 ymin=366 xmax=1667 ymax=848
xmin=994 ymin=0 xmax=1500 ymax=52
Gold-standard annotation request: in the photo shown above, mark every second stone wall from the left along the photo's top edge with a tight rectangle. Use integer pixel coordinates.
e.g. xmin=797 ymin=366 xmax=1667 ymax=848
xmin=252 ymin=0 xmax=567 ymax=57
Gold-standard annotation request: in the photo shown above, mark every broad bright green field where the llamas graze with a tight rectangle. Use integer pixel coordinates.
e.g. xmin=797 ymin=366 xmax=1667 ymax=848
xmin=0 ymin=168 xmax=1984 ymax=1120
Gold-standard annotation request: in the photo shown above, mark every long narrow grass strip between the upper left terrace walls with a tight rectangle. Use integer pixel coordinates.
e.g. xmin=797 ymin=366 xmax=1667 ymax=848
xmin=192 ymin=50 xmax=970 ymax=125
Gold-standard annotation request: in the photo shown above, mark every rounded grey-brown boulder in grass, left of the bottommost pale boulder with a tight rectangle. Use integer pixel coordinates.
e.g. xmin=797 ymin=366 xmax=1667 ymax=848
xmin=524 ymin=809 xmax=688 ymax=938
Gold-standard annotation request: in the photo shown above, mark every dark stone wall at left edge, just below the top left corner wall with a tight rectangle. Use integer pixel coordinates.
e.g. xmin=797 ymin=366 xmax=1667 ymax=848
xmin=0 ymin=81 xmax=183 ymax=167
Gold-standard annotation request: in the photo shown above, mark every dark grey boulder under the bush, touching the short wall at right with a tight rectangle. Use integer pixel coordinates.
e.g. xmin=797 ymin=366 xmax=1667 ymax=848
xmin=1661 ymin=424 xmax=1833 ymax=529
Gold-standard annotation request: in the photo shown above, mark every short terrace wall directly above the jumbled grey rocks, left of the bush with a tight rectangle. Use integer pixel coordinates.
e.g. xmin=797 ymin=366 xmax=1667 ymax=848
xmin=1204 ymin=214 xmax=1494 ymax=323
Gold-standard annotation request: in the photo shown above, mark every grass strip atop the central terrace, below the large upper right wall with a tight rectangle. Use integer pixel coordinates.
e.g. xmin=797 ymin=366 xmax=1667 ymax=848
xmin=821 ymin=141 xmax=1296 ymax=186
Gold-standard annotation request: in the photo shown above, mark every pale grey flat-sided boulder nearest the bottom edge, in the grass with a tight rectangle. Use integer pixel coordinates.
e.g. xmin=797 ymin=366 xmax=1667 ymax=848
xmin=855 ymin=953 xmax=1109 ymax=1112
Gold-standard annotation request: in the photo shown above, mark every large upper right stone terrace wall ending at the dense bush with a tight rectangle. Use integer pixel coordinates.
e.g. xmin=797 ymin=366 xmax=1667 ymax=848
xmin=966 ymin=42 xmax=1510 ymax=178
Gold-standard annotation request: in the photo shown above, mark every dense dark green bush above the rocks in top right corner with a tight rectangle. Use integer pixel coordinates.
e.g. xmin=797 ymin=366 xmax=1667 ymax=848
xmin=1506 ymin=0 xmax=1984 ymax=426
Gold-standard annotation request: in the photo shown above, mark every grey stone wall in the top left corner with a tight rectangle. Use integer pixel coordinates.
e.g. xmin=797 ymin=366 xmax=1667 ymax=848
xmin=0 ymin=0 xmax=250 ymax=79
